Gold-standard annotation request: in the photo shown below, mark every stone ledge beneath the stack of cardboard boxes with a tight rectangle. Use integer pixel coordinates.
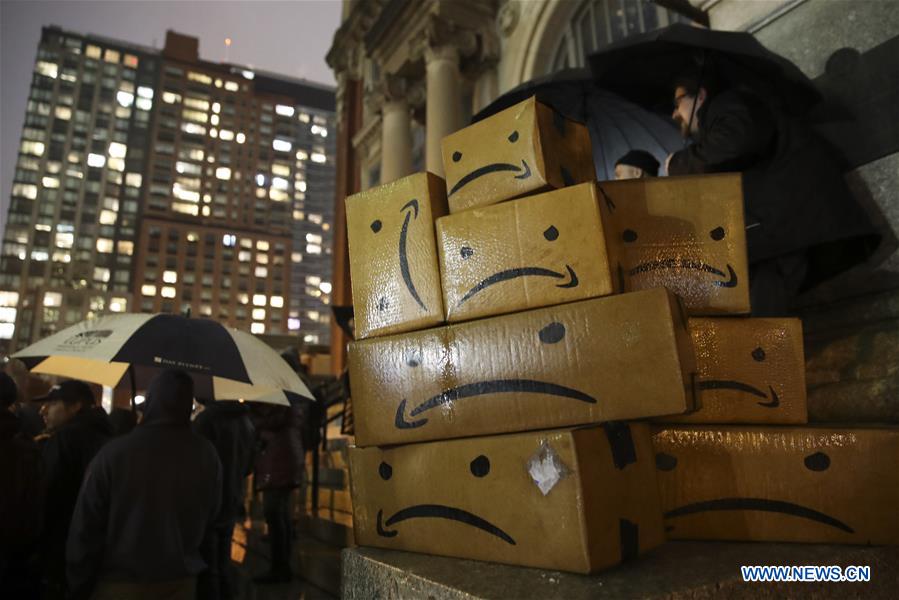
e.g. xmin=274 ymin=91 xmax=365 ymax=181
xmin=341 ymin=542 xmax=899 ymax=600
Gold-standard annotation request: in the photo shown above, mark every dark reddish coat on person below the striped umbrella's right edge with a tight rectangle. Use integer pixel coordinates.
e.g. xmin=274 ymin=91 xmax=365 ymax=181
xmin=253 ymin=405 xmax=305 ymax=490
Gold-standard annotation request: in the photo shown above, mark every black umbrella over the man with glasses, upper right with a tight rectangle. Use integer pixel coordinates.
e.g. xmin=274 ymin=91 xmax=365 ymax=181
xmin=589 ymin=23 xmax=821 ymax=114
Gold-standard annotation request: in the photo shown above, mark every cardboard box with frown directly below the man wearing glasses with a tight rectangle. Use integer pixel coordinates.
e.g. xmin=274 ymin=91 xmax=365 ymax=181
xmin=598 ymin=174 xmax=749 ymax=316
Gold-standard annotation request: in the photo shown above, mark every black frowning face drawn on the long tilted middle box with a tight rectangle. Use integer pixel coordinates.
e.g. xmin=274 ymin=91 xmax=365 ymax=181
xmin=394 ymin=321 xmax=597 ymax=429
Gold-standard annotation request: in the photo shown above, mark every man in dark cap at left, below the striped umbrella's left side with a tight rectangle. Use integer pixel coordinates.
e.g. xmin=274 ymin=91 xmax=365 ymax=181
xmin=34 ymin=380 xmax=112 ymax=598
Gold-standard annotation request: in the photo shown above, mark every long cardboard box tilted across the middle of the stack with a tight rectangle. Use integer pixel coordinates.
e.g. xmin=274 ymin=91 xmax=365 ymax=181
xmin=347 ymin=289 xmax=695 ymax=446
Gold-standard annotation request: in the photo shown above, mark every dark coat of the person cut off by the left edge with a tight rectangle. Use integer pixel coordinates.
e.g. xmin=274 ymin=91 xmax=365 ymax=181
xmin=0 ymin=408 xmax=43 ymax=562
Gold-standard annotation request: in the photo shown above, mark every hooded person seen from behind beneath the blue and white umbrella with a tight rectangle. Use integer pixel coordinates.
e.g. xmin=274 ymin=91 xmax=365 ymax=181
xmin=66 ymin=369 xmax=222 ymax=600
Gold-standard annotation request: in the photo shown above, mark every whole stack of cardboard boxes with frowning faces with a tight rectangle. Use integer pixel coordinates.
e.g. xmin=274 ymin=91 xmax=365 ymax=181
xmin=347 ymin=99 xmax=899 ymax=573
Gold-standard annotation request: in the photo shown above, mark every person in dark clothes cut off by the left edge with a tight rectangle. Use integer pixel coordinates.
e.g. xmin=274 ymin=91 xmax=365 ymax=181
xmin=0 ymin=372 xmax=43 ymax=598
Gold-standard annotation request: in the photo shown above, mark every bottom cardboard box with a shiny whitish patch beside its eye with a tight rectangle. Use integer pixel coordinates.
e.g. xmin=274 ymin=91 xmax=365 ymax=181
xmin=350 ymin=424 xmax=664 ymax=573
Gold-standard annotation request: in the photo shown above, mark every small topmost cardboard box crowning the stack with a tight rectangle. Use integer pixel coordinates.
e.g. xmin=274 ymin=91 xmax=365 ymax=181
xmin=441 ymin=97 xmax=596 ymax=213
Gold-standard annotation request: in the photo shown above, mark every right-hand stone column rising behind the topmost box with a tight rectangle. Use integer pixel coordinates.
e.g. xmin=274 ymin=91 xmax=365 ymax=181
xmin=425 ymin=45 xmax=463 ymax=177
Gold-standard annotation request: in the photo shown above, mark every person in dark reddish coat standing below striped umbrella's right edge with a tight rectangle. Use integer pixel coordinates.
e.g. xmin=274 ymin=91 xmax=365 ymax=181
xmin=253 ymin=404 xmax=305 ymax=584
